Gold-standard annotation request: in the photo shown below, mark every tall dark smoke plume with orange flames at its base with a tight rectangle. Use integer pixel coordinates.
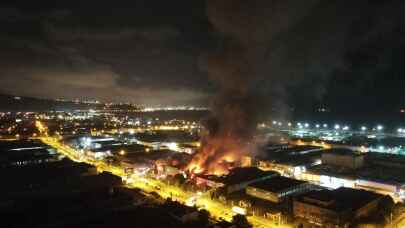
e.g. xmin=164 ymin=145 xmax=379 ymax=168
xmin=189 ymin=0 xmax=317 ymax=174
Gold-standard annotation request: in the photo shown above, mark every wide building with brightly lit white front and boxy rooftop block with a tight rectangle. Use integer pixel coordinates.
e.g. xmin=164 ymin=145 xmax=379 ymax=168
xmin=300 ymin=150 xmax=405 ymax=202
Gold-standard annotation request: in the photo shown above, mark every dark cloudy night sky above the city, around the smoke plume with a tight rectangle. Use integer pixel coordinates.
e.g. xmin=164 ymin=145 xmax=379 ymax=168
xmin=0 ymin=0 xmax=405 ymax=114
